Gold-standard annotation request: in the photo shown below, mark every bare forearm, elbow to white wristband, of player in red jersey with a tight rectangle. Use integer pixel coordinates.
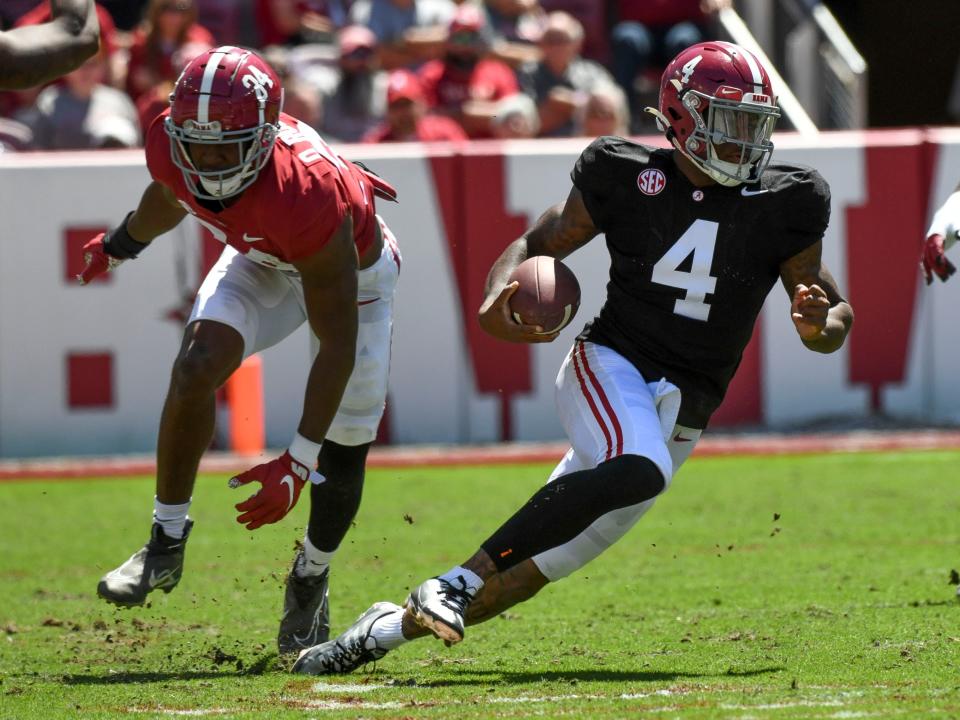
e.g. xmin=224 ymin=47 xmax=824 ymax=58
xmin=297 ymin=324 xmax=357 ymax=443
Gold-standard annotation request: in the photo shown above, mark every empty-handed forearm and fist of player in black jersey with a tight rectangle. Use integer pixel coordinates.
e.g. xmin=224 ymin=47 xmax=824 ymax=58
xmin=780 ymin=241 xmax=853 ymax=353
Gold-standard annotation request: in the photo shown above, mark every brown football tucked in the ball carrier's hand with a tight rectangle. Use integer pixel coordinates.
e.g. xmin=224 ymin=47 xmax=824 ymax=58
xmin=510 ymin=255 xmax=580 ymax=335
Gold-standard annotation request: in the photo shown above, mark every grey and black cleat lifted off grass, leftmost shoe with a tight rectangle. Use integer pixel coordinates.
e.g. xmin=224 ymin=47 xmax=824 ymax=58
xmin=97 ymin=520 xmax=193 ymax=607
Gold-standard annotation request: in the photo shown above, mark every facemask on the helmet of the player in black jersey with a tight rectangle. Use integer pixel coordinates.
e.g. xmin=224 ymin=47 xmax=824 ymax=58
xmin=677 ymin=87 xmax=780 ymax=187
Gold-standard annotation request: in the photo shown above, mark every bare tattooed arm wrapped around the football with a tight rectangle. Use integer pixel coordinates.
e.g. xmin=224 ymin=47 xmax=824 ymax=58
xmin=479 ymin=187 xmax=600 ymax=343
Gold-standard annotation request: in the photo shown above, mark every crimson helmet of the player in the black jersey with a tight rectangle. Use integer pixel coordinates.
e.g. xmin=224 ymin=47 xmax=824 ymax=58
xmin=647 ymin=41 xmax=780 ymax=186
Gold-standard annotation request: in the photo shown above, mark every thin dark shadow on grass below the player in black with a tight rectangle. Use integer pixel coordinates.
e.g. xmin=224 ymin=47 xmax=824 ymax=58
xmin=421 ymin=665 xmax=785 ymax=687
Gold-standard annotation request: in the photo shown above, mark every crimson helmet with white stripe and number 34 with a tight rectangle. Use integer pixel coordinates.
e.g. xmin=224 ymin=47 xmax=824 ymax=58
xmin=164 ymin=45 xmax=283 ymax=200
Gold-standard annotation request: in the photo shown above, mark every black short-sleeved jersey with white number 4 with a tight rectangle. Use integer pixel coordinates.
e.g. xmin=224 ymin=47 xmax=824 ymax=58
xmin=571 ymin=137 xmax=830 ymax=428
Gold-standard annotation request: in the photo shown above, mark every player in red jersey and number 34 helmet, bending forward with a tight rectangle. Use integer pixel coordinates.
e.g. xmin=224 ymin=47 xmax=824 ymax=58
xmin=80 ymin=47 xmax=400 ymax=654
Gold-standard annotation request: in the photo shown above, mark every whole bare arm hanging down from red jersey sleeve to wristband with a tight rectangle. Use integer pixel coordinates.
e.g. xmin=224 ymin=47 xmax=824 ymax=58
xmin=293 ymin=215 xmax=359 ymax=443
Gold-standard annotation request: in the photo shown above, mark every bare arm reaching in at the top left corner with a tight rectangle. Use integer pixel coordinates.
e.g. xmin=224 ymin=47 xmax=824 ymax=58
xmin=0 ymin=0 xmax=100 ymax=90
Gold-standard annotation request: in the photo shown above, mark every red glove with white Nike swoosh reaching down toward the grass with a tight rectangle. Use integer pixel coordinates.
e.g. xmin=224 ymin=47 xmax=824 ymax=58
xmin=229 ymin=450 xmax=324 ymax=530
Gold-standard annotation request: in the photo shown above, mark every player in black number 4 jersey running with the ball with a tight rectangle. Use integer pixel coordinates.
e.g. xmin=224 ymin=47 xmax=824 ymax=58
xmin=294 ymin=42 xmax=853 ymax=674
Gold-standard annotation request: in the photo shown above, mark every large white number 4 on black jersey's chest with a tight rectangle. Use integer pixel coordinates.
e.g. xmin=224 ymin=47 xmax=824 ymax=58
xmin=651 ymin=220 xmax=720 ymax=322
